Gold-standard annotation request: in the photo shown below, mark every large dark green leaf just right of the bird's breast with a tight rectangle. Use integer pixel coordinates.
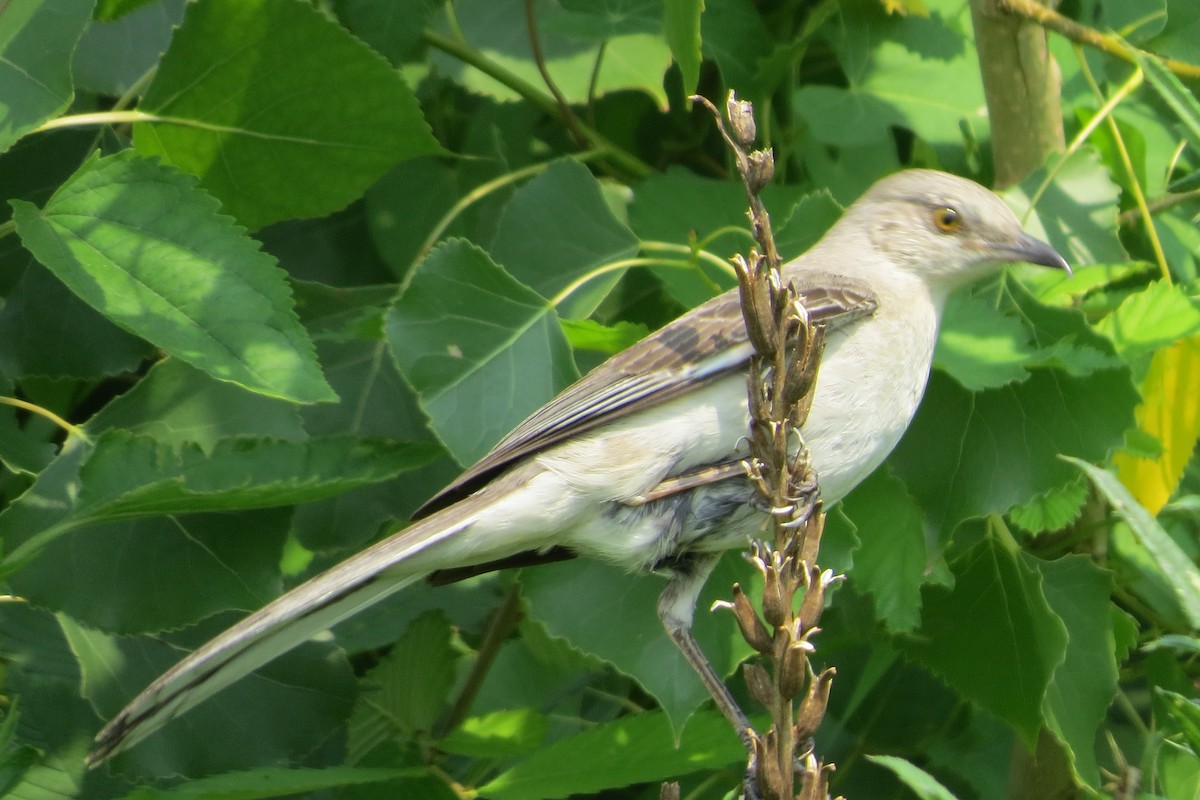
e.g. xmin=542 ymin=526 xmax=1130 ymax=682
xmin=890 ymin=369 xmax=1138 ymax=541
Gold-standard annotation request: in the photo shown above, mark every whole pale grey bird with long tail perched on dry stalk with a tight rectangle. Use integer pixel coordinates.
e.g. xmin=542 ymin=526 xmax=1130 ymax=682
xmin=88 ymin=169 xmax=1070 ymax=766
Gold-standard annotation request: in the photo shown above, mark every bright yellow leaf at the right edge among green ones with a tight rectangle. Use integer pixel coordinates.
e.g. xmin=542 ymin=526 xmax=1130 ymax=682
xmin=1114 ymin=337 xmax=1200 ymax=515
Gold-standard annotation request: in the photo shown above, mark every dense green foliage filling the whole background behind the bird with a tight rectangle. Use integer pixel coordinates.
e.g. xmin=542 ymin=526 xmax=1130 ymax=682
xmin=0 ymin=0 xmax=1200 ymax=800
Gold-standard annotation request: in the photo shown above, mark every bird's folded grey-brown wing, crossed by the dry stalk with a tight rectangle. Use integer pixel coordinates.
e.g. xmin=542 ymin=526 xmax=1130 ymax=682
xmin=414 ymin=269 xmax=877 ymax=518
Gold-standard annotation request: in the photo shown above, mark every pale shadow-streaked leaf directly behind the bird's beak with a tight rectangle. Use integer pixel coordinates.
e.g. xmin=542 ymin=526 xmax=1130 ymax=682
xmin=1003 ymin=148 xmax=1128 ymax=266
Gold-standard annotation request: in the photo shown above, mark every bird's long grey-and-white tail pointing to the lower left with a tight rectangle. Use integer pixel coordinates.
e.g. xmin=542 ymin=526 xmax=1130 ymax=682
xmin=88 ymin=495 xmax=487 ymax=766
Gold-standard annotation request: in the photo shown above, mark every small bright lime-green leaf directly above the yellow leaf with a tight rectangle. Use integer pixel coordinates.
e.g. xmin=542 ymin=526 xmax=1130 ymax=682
xmin=1096 ymin=281 xmax=1200 ymax=357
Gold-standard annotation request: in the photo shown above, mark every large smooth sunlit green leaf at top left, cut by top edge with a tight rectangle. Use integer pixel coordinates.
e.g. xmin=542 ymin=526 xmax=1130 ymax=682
xmin=133 ymin=0 xmax=438 ymax=229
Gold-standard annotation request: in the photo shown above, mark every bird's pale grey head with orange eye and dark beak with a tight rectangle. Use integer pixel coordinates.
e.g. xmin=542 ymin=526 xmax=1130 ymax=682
xmin=846 ymin=169 xmax=1070 ymax=294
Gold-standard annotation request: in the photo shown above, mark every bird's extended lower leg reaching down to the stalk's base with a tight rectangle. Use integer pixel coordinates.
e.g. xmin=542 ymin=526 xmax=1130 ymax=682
xmin=659 ymin=554 xmax=760 ymax=800
